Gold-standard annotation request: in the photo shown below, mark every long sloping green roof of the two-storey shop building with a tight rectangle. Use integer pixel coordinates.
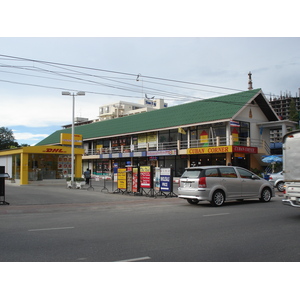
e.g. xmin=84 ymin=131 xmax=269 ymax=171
xmin=37 ymin=89 xmax=268 ymax=146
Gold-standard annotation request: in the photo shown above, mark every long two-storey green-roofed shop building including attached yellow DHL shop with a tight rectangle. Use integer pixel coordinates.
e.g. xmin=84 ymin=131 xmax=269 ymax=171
xmin=0 ymin=89 xmax=297 ymax=184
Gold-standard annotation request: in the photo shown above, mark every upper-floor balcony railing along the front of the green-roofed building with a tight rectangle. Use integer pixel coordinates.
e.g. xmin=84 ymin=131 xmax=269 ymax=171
xmin=85 ymin=136 xmax=270 ymax=156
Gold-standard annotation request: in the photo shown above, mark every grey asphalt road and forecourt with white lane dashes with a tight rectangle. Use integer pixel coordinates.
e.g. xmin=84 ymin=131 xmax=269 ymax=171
xmin=0 ymin=180 xmax=300 ymax=262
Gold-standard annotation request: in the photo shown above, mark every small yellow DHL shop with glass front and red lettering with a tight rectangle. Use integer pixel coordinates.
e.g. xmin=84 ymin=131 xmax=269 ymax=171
xmin=0 ymin=146 xmax=84 ymax=185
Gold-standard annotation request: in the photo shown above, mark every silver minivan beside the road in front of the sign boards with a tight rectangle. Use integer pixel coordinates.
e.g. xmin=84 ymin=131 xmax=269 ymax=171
xmin=178 ymin=166 xmax=275 ymax=206
